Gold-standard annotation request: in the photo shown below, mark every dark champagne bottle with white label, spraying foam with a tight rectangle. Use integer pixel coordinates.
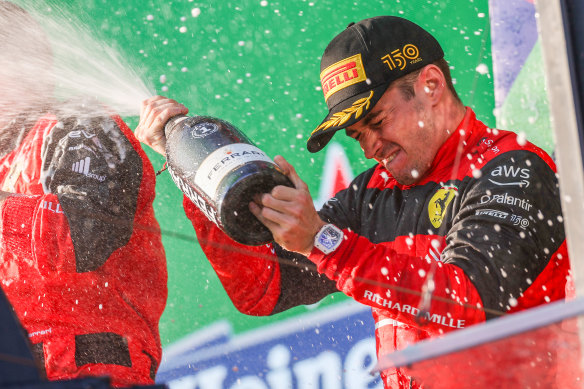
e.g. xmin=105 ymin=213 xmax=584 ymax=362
xmin=165 ymin=115 xmax=293 ymax=246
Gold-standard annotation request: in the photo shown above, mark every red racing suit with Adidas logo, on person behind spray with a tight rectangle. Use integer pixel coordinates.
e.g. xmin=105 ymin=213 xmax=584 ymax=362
xmin=0 ymin=107 xmax=167 ymax=386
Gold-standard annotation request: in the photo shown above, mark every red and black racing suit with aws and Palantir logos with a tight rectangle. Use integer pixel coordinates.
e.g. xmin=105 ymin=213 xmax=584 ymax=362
xmin=184 ymin=108 xmax=569 ymax=388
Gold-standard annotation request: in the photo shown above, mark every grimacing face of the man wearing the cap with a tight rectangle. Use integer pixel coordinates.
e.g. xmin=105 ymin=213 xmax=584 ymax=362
xmin=346 ymin=80 xmax=441 ymax=185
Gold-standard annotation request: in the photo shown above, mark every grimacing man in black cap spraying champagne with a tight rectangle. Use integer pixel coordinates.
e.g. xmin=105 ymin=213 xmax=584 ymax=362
xmin=137 ymin=16 xmax=569 ymax=388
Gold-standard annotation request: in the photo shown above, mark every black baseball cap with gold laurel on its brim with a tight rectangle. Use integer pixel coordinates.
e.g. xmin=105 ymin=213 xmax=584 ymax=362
xmin=307 ymin=16 xmax=444 ymax=153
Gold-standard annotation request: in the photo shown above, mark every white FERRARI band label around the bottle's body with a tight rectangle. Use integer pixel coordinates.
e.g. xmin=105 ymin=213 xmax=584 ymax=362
xmin=195 ymin=143 xmax=274 ymax=199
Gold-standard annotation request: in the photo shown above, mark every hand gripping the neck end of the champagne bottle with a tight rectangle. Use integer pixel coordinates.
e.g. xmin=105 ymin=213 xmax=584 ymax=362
xmin=134 ymin=96 xmax=189 ymax=157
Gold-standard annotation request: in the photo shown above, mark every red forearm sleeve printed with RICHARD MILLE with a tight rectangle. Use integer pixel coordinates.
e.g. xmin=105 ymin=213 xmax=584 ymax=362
xmin=308 ymin=229 xmax=485 ymax=332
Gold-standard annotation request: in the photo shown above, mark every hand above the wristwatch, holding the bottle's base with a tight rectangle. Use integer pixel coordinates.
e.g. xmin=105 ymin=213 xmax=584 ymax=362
xmin=249 ymin=156 xmax=326 ymax=255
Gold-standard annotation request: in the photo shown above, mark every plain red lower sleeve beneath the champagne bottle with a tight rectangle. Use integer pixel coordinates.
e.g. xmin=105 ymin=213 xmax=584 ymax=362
xmin=183 ymin=197 xmax=280 ymax=316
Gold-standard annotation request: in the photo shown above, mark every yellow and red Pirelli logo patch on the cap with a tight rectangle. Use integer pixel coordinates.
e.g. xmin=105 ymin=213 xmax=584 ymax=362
xmin=320 ymin=54 xmax=367 ymax=101
